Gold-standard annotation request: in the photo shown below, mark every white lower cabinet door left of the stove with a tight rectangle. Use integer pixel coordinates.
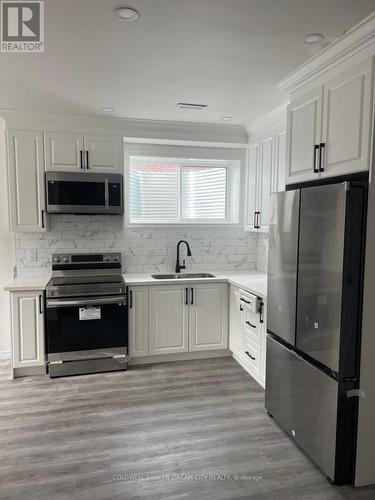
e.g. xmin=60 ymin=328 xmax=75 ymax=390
xmin=11 ymin=292 xmax=44 ymax=368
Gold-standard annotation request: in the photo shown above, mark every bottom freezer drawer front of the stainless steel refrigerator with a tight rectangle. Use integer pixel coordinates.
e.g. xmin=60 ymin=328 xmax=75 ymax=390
xmin=265 ymin=336 xmax=338 ymax=480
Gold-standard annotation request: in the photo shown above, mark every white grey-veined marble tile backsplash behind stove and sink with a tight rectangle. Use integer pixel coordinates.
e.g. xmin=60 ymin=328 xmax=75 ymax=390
xmin=16 ymin=215 xmax=267 ymax=276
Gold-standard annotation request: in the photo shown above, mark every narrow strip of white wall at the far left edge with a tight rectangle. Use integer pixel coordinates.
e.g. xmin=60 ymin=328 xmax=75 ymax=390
xmin=0 ymin=119 xmax=14 ymax=357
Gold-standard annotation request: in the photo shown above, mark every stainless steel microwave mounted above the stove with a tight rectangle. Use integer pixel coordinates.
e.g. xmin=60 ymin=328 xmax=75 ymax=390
xmin=46 ymin=172 xmax=123 ymax=214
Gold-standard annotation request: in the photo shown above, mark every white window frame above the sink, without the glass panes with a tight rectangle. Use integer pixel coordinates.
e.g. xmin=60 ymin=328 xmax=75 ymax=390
xmin=123 ymin=142 xmax=246 ymax=229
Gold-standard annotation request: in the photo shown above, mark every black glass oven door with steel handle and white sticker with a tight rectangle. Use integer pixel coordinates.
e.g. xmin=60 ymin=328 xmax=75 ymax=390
xmin=46 ymin=295 xmax=128 ymax=362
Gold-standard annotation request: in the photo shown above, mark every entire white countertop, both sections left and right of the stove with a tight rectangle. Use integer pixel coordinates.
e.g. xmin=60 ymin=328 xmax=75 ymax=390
xmin=4 ymin=271 xmax=267 ymax=299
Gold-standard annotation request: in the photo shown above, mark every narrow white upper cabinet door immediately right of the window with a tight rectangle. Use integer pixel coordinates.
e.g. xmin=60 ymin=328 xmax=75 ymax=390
xmin=245 ymin=140 xmax=259 ymax=231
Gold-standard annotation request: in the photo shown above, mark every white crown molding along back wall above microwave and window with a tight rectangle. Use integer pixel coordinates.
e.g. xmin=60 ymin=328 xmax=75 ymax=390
xmin=0 ymin=109 xmax=248 ymax=144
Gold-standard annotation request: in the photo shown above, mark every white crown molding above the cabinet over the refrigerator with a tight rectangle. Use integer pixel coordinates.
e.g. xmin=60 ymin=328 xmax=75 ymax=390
xmin=277 ymin=11 xmax=375 ymax=94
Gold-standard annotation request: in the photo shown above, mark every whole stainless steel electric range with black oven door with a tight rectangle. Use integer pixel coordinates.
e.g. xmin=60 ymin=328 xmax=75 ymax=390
xmin=46 ymin=253 xmax=128 ymax=377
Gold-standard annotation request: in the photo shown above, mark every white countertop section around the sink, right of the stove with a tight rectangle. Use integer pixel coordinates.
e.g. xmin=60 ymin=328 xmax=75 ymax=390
xmin=124 ymin=271 xmax=267 ymax=299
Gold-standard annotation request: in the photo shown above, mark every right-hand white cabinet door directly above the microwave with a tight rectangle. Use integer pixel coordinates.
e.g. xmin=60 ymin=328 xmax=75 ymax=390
xmin=85 ymin=134 xmax=122 ymax=173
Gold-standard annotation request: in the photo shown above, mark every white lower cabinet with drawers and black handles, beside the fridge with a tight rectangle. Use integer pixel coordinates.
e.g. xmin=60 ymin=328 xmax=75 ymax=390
xmin=229 ymin=286 xmax=266 ymax=387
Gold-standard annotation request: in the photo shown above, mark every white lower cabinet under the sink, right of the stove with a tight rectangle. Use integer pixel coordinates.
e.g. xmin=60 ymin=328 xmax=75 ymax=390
xmin=129 ymin=283 xmax=228 ymax=358
